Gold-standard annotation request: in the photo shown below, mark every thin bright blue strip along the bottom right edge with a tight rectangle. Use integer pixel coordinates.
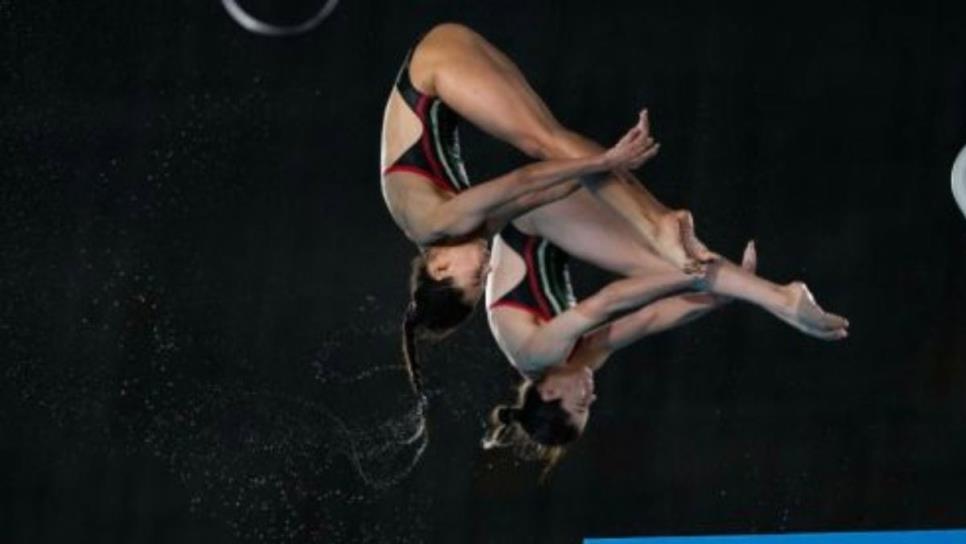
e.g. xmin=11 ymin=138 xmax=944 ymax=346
xmin=584 ymin=530 xmax=966 ymax=544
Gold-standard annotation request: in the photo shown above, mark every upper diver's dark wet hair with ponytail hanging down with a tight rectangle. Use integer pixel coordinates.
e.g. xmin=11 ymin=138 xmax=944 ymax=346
xmin=402 ymin=255 xmax=474 ymax=398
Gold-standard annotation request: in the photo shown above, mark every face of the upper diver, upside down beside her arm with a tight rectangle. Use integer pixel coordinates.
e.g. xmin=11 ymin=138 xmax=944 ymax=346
xmin=426 ymin=238 xmax=490 ymax=305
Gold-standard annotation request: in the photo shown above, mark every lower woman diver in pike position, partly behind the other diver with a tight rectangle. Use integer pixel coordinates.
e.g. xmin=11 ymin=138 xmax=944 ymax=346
xmin=484 ymin=207 xmax=848 ymax=464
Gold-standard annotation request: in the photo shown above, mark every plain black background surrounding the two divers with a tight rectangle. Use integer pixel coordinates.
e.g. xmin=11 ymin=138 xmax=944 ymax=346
xmin=0 ymin=0 xmax=966 ymax=543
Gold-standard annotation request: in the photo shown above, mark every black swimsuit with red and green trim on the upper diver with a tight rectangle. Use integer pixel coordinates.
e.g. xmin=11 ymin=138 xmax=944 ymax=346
xmin=383 ymin=51 xmax=470 ymax=193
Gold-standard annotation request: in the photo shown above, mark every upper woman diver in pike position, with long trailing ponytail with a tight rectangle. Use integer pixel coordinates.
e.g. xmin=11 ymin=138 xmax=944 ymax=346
xmin=381 ymin=24 xmax=713 ymax=382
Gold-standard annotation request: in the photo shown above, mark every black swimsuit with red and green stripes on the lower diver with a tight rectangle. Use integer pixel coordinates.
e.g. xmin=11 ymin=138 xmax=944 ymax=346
xmin=490 ymin=224 xmax=577 ymax=321
